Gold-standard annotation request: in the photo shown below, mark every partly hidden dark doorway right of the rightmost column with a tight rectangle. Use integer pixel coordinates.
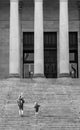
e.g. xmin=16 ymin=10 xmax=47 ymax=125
xmin=69 ymin=32 xmax=78 ymax=78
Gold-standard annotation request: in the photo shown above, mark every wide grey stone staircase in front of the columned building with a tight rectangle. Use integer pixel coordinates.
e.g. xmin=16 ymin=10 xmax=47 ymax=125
xmin=0 ymin=78 xmax=80 ymax=130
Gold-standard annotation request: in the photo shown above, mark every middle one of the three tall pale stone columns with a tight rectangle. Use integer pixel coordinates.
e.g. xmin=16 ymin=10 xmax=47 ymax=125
xmin=34 ymin=0 xmax=44 ymax=77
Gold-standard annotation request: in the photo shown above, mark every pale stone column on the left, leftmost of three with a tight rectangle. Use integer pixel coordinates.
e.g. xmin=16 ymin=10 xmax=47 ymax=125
xmin=9 ymin=0 xmax=20 ymax=77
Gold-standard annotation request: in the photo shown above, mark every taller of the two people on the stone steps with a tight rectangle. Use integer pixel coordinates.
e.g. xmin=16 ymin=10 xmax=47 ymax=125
xmin=17 ymin=93 xmax=25 ymax=116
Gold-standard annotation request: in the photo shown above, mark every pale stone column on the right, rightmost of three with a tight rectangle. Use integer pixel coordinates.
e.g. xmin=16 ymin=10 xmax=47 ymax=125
xmin=59 ymin=0 xmax=69 ymax=77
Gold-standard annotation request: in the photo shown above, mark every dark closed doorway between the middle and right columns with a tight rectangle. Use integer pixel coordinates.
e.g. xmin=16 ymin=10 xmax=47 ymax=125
xmin=44 ymin=32 xmax=57 ymax=78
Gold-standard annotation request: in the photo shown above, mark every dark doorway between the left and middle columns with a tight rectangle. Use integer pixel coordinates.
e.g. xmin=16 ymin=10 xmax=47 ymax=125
xmin=23 ymin=32 xmax=34 ymax=78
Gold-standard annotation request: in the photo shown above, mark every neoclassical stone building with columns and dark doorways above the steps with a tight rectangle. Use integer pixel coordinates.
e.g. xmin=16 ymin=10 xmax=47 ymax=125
xmin=0 ymin=0 xmax=80 ymax=78
